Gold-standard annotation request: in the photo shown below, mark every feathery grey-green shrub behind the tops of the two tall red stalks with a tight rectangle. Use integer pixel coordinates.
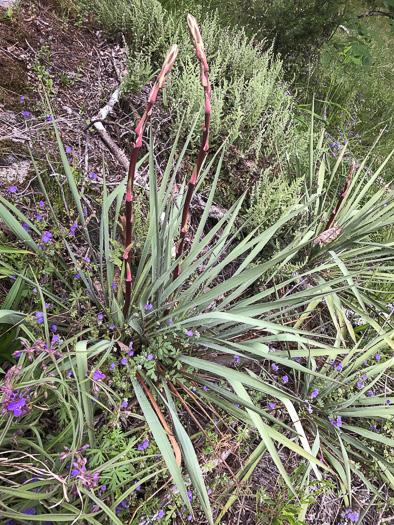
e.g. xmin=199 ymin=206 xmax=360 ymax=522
xmin=96 ymin=0 xmax=294 ymax=157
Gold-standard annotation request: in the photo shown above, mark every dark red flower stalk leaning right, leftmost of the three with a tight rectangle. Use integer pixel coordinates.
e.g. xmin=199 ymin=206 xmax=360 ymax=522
xmin=123 ymin=44 xmax=178 ymax=316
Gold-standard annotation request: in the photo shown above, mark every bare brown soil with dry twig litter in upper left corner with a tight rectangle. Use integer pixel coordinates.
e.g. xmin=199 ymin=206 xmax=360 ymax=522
xmin=0 ymin=0 xmax=138 ymax=196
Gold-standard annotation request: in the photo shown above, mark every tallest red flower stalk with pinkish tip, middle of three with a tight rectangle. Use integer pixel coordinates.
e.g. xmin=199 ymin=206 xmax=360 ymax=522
xmin=173 ymin=15 xmax=211 ymax=279
